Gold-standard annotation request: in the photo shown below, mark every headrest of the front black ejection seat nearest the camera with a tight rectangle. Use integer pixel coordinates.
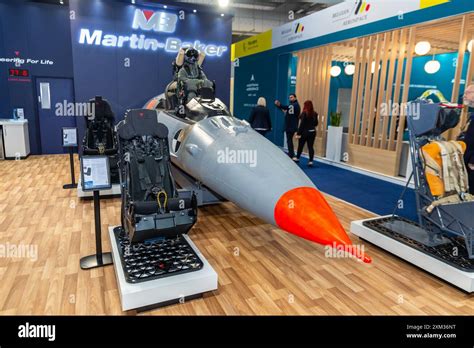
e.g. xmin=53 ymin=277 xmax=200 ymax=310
xmin=117 ymin=109 xmax=168 ymax=140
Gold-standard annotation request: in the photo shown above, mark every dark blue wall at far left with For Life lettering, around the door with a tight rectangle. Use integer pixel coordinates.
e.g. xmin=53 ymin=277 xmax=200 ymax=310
xmin=0 ymin=1 xmax=73 ymax=154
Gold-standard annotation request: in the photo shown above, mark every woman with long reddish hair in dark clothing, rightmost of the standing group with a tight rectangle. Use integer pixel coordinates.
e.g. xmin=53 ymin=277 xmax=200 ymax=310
xmin=296 ymin=100 xmax=318 ymax=167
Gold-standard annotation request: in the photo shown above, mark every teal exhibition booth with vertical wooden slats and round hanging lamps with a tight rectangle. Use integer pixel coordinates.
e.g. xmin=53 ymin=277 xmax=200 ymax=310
xmin=233 ymin=1 xmax=473 ymax=177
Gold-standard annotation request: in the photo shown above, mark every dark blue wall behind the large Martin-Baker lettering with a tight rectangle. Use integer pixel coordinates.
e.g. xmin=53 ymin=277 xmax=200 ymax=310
xmin=70 ymin=0 xmax=232 ymax=145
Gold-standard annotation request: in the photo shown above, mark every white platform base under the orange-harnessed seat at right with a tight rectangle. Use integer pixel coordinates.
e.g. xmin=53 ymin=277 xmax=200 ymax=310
xmin=351 ymin=219 xmax=474 ymax=293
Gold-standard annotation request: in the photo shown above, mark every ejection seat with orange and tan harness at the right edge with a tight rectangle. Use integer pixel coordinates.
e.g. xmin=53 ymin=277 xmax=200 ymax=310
xmin=407 ymin=100 xmax=474 ymax=259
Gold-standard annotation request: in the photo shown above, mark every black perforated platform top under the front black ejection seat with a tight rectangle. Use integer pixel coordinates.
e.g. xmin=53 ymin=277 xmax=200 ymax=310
xmin=114 ymin=227 xmax=203 ymax=283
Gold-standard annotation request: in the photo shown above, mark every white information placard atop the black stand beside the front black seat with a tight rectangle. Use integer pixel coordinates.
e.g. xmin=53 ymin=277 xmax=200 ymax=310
xmin=81 ymin=156 xmax=112 ymax=191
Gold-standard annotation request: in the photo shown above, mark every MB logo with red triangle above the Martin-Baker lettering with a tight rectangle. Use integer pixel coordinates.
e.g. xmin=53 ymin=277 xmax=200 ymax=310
xmin=132 ymin=8 xmax=178 ymax=33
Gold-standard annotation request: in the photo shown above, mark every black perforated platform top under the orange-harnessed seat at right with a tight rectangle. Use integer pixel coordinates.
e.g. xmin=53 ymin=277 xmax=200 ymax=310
xmin=363 ymin=216 xmax=474 ymax=272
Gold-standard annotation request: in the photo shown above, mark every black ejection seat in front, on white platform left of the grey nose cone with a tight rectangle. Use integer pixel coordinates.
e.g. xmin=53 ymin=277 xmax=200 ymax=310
xmin=117 ymin=109 xmax=197 ymax=243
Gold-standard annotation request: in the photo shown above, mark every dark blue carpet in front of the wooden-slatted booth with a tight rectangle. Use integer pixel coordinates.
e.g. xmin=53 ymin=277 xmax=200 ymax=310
xmin=299 ymin=157 xmax=417 ymax=221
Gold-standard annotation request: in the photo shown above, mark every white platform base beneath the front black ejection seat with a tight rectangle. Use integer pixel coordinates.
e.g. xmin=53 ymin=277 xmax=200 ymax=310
xmin=109 ymin=227 xmax=217 ymax=311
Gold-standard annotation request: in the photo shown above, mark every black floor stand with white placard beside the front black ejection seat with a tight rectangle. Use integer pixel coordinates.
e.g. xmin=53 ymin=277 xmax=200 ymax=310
xmin=80 ymin=156 xmax=113 ymax=269
